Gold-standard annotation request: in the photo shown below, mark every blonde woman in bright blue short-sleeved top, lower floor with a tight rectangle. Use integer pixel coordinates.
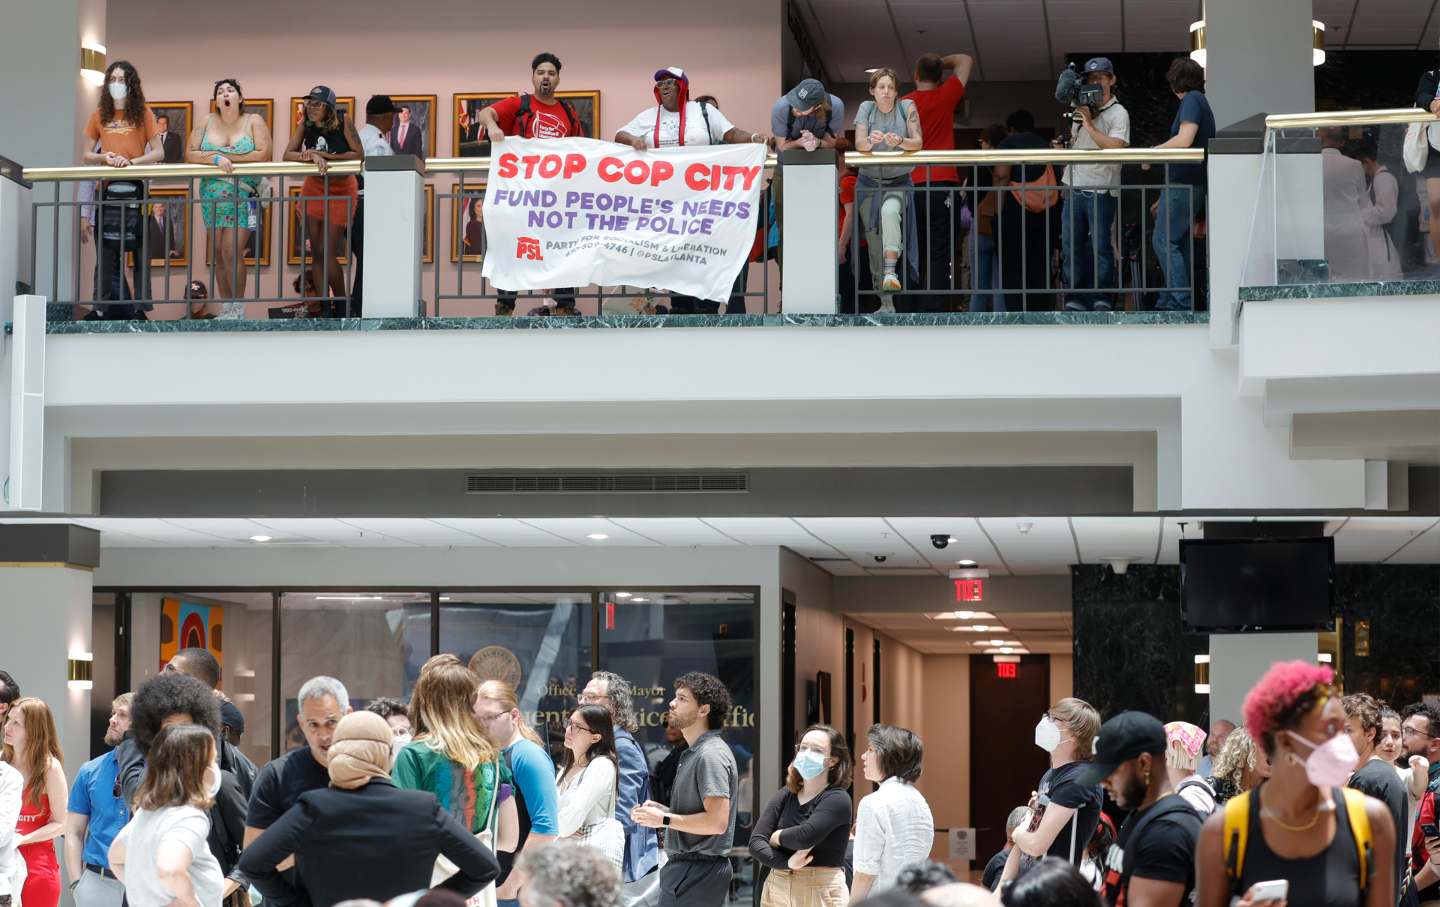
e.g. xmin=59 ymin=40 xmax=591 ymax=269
xmin=474 ymin=681 xmax=560 ymax=907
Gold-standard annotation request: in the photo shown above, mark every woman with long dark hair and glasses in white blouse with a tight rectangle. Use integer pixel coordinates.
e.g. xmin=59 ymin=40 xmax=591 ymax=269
xmin=554 ymin=705 xmax=625 ymax=870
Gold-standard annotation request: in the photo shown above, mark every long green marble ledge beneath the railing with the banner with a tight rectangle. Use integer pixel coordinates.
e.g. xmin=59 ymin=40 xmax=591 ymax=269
xmin=46 ymin=312 xmax=1210 ymax=334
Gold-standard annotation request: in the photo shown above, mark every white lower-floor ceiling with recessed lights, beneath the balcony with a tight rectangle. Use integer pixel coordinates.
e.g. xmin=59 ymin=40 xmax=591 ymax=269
xmin=11 ymin=517 xmax=1440 ymax=576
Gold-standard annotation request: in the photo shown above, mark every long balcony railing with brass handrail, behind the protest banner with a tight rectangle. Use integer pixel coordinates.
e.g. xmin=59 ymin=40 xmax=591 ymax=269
xmin=8 ymin=148 xmax=1207 ymax=320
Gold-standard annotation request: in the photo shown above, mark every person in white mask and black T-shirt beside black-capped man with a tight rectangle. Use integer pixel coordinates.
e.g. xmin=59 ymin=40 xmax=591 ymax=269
xmin=1004 ymin=698 xmax=1103 ymax=878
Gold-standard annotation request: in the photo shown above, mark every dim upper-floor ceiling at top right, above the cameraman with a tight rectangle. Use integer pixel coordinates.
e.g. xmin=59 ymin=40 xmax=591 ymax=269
xmin=795 ymin=0 xmax=1440 ymax=82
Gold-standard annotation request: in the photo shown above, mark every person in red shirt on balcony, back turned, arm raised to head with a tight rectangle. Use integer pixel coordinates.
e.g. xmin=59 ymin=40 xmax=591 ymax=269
xmin=904 ymin=53 xmax=975 ymax=312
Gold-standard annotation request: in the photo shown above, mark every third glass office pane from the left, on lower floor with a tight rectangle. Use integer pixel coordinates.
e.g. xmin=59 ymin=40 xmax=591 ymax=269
xmin=439 ymin=592 xmax=593 ymax=759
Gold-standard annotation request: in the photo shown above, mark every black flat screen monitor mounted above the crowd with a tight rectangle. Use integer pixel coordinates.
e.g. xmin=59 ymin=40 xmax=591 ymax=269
xmin=1179 ymin=537 xmax=1335 ymax=632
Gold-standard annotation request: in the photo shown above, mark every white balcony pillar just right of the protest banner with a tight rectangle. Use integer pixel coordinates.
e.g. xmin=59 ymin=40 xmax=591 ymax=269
xmin=780 ymin=148 xmax=840 ymax=315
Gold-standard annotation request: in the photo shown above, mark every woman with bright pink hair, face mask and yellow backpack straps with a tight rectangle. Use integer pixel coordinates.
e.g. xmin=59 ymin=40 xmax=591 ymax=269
xmin=1195 ymin=661 xmax=1395 ymax=907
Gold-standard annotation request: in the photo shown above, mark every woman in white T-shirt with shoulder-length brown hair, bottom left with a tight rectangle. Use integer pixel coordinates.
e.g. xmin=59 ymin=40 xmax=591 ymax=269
xmin=109 ymin=724 xmax=225 ymax=907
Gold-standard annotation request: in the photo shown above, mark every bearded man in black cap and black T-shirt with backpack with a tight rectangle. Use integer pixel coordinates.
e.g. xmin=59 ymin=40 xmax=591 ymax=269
xmin=1077 ymin=711 xmax=1201 ymax=907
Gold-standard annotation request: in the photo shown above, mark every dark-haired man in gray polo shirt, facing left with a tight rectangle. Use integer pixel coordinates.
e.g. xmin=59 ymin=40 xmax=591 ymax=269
xmin=631 ymin=671 xmax=739 ymax=907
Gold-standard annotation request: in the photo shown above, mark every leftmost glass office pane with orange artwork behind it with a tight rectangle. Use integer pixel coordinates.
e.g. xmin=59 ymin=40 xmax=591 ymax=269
xmin=130 ymin=590 xmax=275 ymax=764
